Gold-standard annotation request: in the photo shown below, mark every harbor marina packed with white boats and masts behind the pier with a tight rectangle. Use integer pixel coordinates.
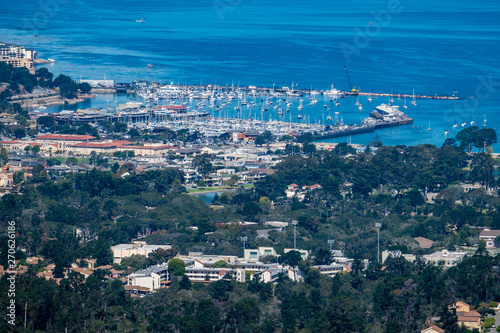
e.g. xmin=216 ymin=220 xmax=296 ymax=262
xmin=41 ymin=84 xmax=413 ymax=140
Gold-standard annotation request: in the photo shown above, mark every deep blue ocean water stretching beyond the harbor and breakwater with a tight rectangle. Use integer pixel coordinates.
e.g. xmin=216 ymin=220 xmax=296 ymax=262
xmin=0 ymin=0 xmax=500 ymax=151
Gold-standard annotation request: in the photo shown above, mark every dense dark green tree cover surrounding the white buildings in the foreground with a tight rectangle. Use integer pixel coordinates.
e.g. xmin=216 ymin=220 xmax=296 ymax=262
xmin=0 ymin=128 xmax=500 ymax=332
